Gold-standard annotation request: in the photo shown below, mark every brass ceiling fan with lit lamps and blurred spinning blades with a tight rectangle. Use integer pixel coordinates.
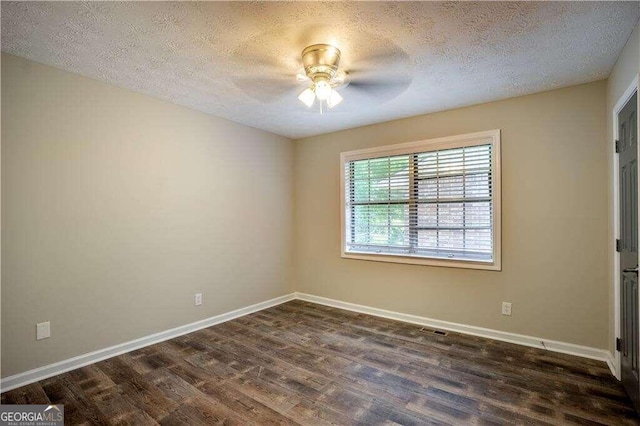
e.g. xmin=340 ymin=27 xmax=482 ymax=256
xmin=232 ymin=27 xmax=414 ymax=112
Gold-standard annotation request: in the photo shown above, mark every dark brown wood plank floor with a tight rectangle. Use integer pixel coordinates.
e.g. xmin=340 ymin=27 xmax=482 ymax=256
xmin=2 ymin=301 xmax=638 ymax=425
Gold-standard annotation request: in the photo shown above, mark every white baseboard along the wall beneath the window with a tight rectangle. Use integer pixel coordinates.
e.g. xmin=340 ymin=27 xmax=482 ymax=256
xmin=295 ymin=292 xmax=618 ymax=377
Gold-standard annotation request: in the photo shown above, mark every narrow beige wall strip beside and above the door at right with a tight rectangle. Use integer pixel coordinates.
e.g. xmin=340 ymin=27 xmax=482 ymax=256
xmin=605 ymin=25 xmax=640 ymax=352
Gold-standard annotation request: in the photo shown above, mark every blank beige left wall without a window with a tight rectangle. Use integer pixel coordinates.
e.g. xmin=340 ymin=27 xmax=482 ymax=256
xmin=2 ymin=54 xmax=293 ymax=377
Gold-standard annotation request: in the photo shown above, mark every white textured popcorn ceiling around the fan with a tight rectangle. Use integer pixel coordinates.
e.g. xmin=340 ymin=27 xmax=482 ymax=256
xmin=1 ymin=2 xmax=640 ymax=138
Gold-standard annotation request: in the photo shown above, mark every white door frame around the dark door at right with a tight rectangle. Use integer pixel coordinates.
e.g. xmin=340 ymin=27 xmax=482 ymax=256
xmin=610 ymin=74 xmax=640 ymax=380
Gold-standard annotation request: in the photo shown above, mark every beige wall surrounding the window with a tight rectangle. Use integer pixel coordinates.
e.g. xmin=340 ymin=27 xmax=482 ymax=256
xmin=294 ymin=81 xmax=610 ymax=348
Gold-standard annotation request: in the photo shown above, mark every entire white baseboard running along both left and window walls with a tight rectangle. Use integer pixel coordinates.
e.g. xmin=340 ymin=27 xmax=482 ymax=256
xmin=0 ymin=292 xmax=619 ymax=392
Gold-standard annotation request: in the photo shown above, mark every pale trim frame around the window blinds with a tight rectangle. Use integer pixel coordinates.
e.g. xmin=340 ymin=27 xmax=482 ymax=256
xmin=340 ymin=129 xmax=502 ymax=271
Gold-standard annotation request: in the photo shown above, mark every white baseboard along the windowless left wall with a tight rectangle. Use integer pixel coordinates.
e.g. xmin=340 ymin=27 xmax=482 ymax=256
xmin=0 ymin=293 xmax=295 ymax=392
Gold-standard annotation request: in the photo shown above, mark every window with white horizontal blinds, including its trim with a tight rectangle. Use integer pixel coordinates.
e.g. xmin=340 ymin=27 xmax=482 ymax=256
xmin=341 ymin=130 xmax=500 ymax=270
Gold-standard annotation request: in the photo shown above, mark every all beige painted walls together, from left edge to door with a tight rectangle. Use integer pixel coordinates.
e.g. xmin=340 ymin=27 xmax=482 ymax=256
xmin=1 ymin=47 xmax=620 ymax=377
